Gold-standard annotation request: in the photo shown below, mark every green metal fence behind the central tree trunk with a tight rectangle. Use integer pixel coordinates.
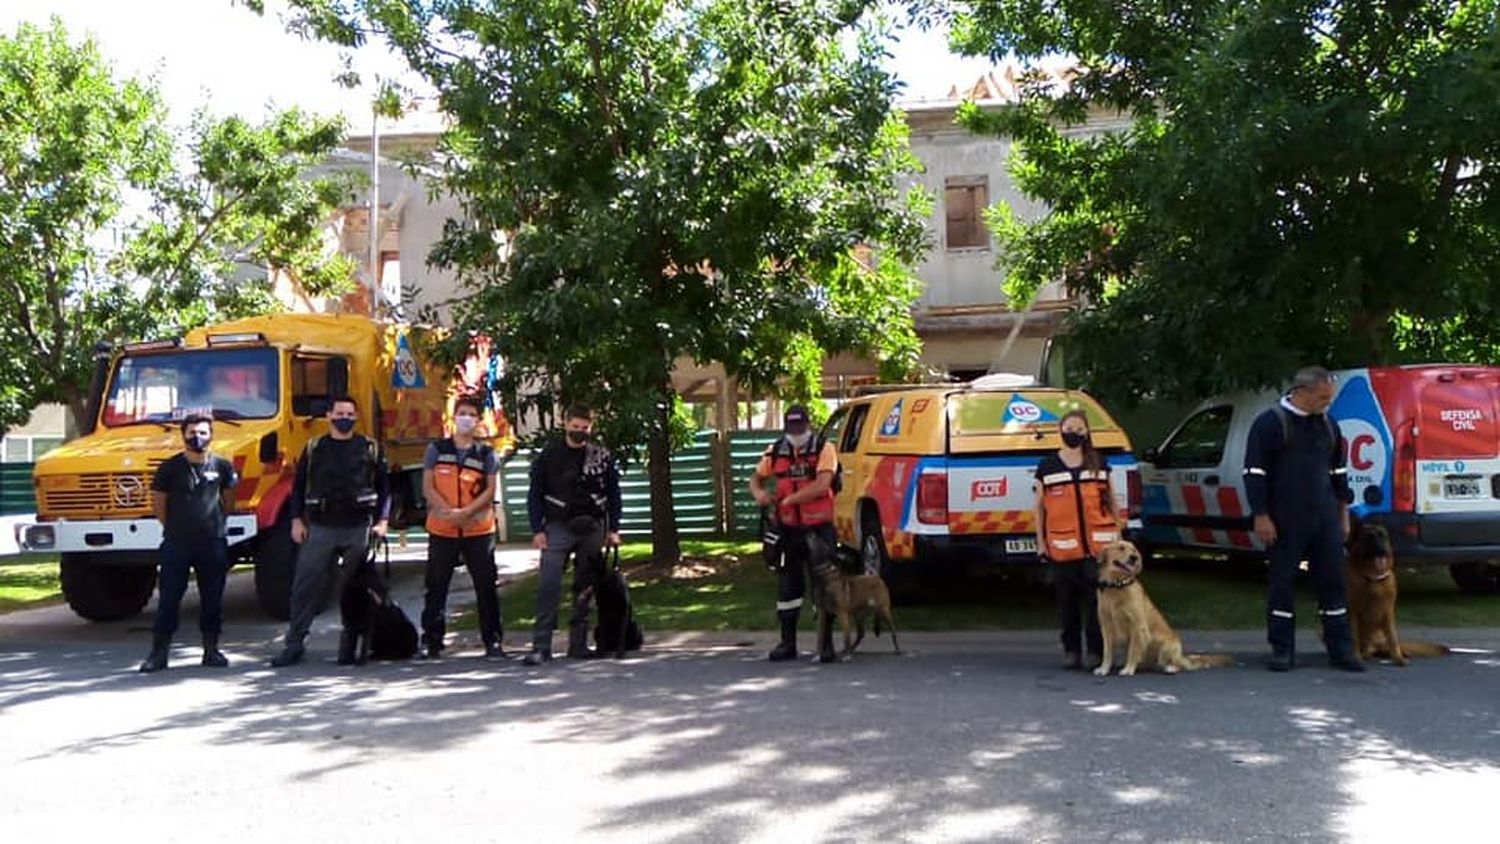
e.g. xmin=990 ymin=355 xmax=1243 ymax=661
xmin=500 ymin=430 xmax=777 ymax=541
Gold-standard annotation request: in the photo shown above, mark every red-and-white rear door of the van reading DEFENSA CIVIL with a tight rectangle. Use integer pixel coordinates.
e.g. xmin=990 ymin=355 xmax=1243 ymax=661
xmin=1416 ymin=367 xmax=1500 ymax=533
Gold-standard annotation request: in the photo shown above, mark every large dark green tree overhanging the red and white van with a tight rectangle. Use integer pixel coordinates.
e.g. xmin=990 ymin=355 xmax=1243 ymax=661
xmin=954 ymin=0 xmax=1500 ymax=399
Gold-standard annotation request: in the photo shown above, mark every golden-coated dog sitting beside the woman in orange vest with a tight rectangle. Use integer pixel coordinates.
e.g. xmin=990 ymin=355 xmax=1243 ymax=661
xmin=1094 ymin=541 xmax=1235 ymax=678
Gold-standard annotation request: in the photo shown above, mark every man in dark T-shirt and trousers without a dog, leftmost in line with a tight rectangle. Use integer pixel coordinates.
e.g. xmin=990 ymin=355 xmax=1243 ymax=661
xmin=141 ymin=415 xmax=239 ymax=672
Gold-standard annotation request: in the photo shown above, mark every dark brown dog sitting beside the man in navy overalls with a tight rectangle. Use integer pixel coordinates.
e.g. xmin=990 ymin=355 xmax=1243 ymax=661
xmin=1344 ymin=516 xmax=1448 ymax=666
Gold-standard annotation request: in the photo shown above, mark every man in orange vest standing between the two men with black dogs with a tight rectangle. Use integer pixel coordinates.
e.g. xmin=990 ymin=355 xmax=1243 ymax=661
xmin=422 ymin=397 xmax=506 ymax=660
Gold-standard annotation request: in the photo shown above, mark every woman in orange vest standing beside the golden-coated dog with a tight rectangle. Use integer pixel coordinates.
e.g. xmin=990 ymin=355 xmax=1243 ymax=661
xmin=1037 ymin=411 xmax=1121 ymax=670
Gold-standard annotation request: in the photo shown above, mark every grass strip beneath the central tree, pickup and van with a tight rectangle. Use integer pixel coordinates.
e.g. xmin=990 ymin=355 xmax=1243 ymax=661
xmin=456 ymin=543 xmax=1500 ymax=631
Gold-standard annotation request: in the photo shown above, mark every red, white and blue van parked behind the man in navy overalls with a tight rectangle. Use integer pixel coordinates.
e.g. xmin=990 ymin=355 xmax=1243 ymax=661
xmin=1142 ymin=364 xmax=1500 ymax=592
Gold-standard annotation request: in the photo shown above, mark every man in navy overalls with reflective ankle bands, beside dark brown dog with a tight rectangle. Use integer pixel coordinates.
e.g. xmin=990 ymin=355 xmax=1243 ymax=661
xmin=1245 ymin=366 xmax=1365 ymax=672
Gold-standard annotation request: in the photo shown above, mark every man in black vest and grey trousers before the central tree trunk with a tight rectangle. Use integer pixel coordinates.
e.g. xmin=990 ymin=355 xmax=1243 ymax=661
xmin=525 ymin=405 xmax=624 ymax=666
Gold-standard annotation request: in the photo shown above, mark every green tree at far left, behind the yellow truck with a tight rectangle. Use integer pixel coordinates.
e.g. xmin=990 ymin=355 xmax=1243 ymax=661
xmin=0 ymin=21 xmax=351 ymax=430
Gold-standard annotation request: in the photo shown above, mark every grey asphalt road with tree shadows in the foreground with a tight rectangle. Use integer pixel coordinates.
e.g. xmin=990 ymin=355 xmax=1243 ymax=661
xmin=0 ymin=551 xmax=1500 ymax=843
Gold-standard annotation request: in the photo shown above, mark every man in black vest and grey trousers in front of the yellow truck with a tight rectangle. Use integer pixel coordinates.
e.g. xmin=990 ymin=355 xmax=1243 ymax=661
xmin=272 ymin=396 xmax=390 ymax=667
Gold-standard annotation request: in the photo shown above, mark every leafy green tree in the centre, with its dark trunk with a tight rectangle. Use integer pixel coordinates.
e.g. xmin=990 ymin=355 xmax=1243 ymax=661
xmin=264 ymin=0 xmax=926 ymax=559
